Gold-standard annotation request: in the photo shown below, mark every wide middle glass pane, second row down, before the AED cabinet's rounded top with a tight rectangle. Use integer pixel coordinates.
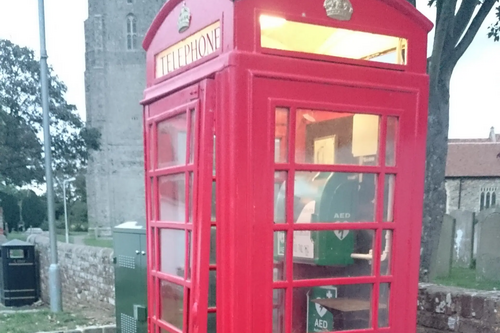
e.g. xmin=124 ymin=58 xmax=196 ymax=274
xmin=294 ymin=171 xmax=377 ymax=223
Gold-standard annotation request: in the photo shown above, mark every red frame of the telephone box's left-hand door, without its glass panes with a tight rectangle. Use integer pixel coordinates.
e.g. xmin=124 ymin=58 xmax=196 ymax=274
xmin=144 ymin=80 xmax=214 ymax=333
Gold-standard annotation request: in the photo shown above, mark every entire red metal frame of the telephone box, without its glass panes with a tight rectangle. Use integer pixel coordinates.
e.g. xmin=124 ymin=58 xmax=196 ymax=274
xmin=143 ymin=0 xmax=431 ymax=333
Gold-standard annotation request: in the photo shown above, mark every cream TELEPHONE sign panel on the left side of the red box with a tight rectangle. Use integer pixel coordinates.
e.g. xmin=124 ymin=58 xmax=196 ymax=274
xmin=155 ymin=21 xmax=221 ymax=78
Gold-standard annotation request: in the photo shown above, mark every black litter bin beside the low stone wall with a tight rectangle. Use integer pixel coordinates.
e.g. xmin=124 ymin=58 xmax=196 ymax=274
xmin=0 ymin=239 xmax=38 ymax=306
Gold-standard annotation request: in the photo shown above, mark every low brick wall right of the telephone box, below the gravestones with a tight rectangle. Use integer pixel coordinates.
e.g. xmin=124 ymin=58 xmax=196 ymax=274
xmin=417 ymin=284 xmax=500 ymax=333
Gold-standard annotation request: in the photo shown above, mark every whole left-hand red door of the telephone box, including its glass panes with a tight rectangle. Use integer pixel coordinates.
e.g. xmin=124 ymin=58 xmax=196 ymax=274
xmin=144 ymin=80 xmax=214 ymax=333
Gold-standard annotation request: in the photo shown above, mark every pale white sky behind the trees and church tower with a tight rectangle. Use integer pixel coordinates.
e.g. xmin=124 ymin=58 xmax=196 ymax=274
xmin=0 ymin=0 xmax=500 ymax=138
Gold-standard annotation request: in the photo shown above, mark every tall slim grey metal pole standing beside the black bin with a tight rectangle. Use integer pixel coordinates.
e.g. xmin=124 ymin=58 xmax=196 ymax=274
xmin=38 ymin=0 xmax=62 ymax=312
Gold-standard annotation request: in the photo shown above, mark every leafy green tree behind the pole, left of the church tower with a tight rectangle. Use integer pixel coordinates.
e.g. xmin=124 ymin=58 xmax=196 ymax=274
xmin=0 ymin=39 xmax=100 ymax=186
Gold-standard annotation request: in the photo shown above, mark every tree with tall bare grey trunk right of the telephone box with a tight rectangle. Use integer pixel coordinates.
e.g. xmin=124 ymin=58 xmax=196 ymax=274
xmin=408 ymin=0 xmax=500 ymax=281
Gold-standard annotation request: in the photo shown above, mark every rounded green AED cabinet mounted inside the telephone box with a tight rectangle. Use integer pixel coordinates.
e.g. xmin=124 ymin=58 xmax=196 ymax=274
xmin=275 ymin=172 xmax=359 ymax=266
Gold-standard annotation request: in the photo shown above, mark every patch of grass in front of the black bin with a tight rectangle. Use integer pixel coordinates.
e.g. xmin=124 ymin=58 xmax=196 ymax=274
xmin=0 ymin=310 xmax=89 ymax=333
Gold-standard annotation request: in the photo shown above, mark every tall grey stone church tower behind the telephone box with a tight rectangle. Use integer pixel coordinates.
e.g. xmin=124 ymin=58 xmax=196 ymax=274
xmin=85 ymin=0 xmax=166 ymax=230
